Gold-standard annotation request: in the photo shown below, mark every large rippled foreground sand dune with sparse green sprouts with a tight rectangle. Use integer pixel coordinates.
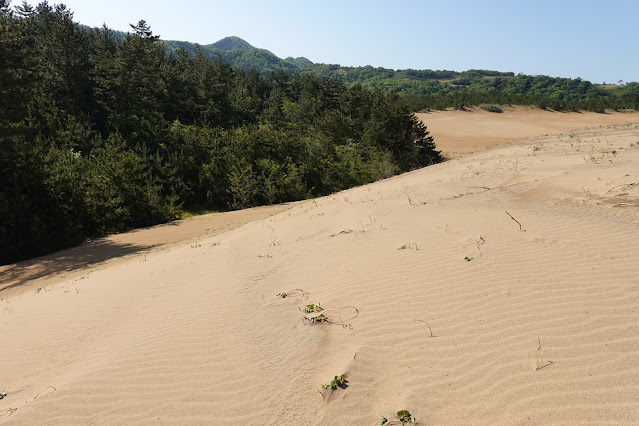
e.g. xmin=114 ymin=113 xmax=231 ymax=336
xmin=0 ymin=111 xmax=639 ymax=425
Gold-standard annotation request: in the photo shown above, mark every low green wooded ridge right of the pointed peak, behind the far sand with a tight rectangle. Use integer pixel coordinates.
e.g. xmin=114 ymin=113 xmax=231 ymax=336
xmin=305 ymin=64 xmax=639 ymax=112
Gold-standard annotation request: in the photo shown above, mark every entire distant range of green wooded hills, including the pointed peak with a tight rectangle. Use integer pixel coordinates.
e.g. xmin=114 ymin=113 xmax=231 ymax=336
xmin=85 ymin=32 xmax=639 ymax=112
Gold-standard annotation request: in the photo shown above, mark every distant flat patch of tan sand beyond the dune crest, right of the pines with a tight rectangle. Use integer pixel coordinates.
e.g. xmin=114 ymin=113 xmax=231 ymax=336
xmin=417 ymin=107 xmax=639 ymax=158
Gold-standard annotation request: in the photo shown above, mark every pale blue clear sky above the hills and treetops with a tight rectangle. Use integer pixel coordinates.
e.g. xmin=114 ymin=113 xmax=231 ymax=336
xmin=42 ymin=0 xmax=639 ymax=83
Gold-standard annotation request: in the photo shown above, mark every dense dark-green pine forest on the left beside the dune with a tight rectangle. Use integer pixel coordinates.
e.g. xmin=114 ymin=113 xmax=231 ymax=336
xmin=0 ymin=0 xmax=441 ymax=264
